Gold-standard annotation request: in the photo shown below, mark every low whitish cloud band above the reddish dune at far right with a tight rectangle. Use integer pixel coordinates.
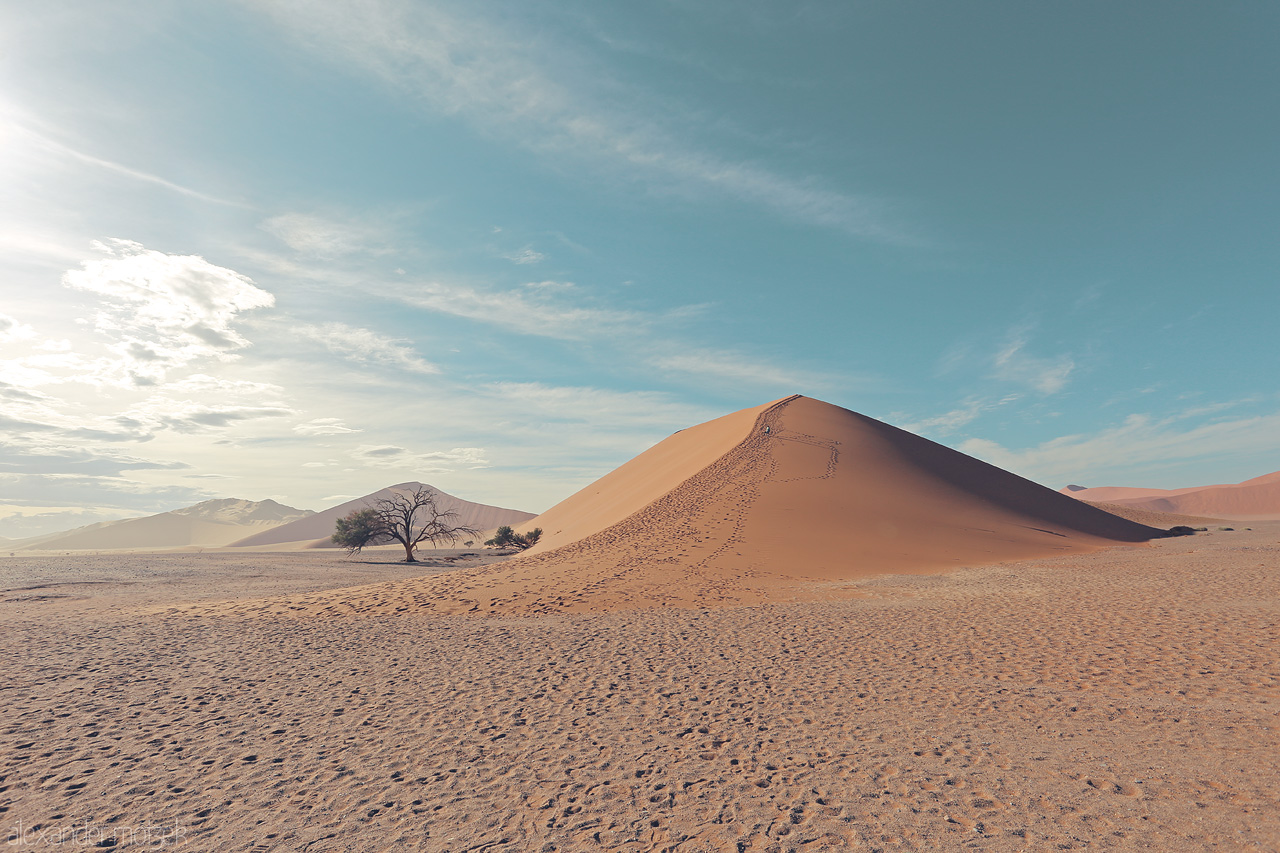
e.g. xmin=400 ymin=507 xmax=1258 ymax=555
xmin=960 ymin=414 xmax=1280 ymax=483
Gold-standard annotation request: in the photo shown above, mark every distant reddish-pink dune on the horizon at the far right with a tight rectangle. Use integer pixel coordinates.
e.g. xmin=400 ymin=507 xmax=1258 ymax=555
xmin=1062 ymin=471 xmax=1280 ymax=520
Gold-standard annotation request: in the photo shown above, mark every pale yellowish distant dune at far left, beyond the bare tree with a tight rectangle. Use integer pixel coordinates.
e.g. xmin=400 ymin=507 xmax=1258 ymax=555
xmin=20 ymin=498 xmax=311 ymax=551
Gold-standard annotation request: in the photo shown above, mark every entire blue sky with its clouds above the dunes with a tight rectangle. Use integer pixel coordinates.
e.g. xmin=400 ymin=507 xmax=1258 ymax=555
xmin=0 ymin=0 xmax=1280 ymax=537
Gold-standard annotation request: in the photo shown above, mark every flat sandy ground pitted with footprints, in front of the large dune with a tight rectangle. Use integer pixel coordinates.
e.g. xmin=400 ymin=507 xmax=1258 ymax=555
xmin=0 ymin=523 xmax=1280 ymax=853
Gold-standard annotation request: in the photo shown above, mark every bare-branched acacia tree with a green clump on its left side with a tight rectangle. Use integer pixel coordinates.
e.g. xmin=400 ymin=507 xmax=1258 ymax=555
xmin=333 ymin=485 xmax=479 ymax=562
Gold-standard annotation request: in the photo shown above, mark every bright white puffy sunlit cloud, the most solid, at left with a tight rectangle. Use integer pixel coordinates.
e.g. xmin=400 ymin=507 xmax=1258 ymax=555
xmin=63 ymin=240 xmax=275 ymax=384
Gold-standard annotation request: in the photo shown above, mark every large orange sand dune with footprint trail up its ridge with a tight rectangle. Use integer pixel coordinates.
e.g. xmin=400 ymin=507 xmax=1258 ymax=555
xmin=240 ymin=396 xmax=1160 ymax=615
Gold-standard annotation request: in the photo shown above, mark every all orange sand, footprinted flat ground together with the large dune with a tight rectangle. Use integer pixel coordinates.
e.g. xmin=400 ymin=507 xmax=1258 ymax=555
xmin=0 ymin=397 xmax=1280 ymax=853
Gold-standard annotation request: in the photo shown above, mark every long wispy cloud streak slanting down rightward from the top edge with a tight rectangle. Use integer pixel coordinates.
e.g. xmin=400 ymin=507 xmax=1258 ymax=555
xmin=247 ymin=0 xmax=904 ymax=241
